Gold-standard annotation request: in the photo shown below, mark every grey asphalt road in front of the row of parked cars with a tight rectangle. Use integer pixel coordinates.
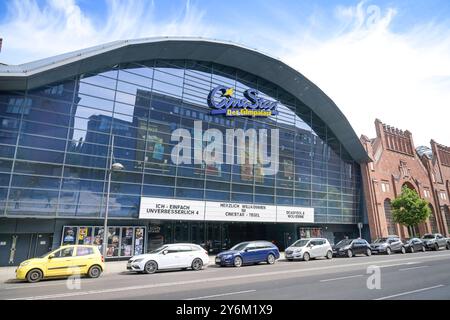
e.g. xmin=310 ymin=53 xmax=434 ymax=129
xmin=0 ymin=251 xmax=450 ymax=300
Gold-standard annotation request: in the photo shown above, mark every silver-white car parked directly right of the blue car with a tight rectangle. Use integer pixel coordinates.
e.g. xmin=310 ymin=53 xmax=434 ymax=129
xmin=284 ymin=238 xmax=333 ymax=261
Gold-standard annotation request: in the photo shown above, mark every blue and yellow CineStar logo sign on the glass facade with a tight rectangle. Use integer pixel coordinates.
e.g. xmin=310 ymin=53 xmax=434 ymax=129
xmin=208 ymin=86 xmax=278 ymax=117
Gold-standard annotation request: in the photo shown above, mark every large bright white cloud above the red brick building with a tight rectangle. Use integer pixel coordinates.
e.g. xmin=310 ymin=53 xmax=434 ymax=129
xmin=282 ymin=2 xmax=450 ymax=146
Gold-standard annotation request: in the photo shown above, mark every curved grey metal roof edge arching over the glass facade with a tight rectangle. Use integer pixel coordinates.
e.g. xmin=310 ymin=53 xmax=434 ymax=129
xmin=0 ymin=37 xmax=371 ymax=162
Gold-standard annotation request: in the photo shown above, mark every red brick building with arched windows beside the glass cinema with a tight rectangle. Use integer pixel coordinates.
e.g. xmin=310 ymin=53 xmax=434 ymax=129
xmin=361 ymin=119 xmax=450 ymax=239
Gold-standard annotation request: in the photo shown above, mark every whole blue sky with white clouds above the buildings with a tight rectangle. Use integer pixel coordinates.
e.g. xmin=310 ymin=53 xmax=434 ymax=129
xmin=0 ymin=0 xmax=450 ymax=145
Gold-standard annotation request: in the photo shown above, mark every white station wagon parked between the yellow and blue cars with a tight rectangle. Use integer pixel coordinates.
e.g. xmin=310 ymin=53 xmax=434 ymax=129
xmin=127 ymin=243 xmax=209 ymax=274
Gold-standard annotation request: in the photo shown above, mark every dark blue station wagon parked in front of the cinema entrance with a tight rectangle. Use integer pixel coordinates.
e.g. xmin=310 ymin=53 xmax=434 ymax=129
xmin=216 ymin=241 xmax=280 ymax=267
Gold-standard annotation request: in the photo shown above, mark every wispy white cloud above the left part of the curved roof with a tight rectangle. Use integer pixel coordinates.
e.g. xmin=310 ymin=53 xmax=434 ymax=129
xmin=0 ymin=0 xmax=212 ymax=64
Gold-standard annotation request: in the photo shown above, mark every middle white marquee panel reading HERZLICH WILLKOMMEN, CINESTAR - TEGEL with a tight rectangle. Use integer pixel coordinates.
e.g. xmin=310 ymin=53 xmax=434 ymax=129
xmin=205 ymin=201 xmax=277 ymax=222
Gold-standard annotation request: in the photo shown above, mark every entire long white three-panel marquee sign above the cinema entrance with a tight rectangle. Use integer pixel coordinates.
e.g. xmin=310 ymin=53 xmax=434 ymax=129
xmin=139 ymin=197 xmax=314 ymax=223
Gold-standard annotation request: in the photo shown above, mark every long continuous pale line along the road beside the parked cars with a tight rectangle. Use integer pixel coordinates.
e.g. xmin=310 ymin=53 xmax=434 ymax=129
xmin=9 ymin=254 xmax=450 ymax=300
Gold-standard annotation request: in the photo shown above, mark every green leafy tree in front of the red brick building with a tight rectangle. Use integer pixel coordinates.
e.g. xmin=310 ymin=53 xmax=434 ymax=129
xmin=391 ymin=186 xmax=431 ymax=235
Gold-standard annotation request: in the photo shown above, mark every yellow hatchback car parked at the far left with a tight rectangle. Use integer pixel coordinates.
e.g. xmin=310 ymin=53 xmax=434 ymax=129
xmin=16 ymin=245 xmax=105 ymax=282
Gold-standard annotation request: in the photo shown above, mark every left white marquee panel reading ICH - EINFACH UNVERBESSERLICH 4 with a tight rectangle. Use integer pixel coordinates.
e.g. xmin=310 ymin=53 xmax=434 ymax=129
xmin=139 ymin=198 xmax=205 ymax=221
